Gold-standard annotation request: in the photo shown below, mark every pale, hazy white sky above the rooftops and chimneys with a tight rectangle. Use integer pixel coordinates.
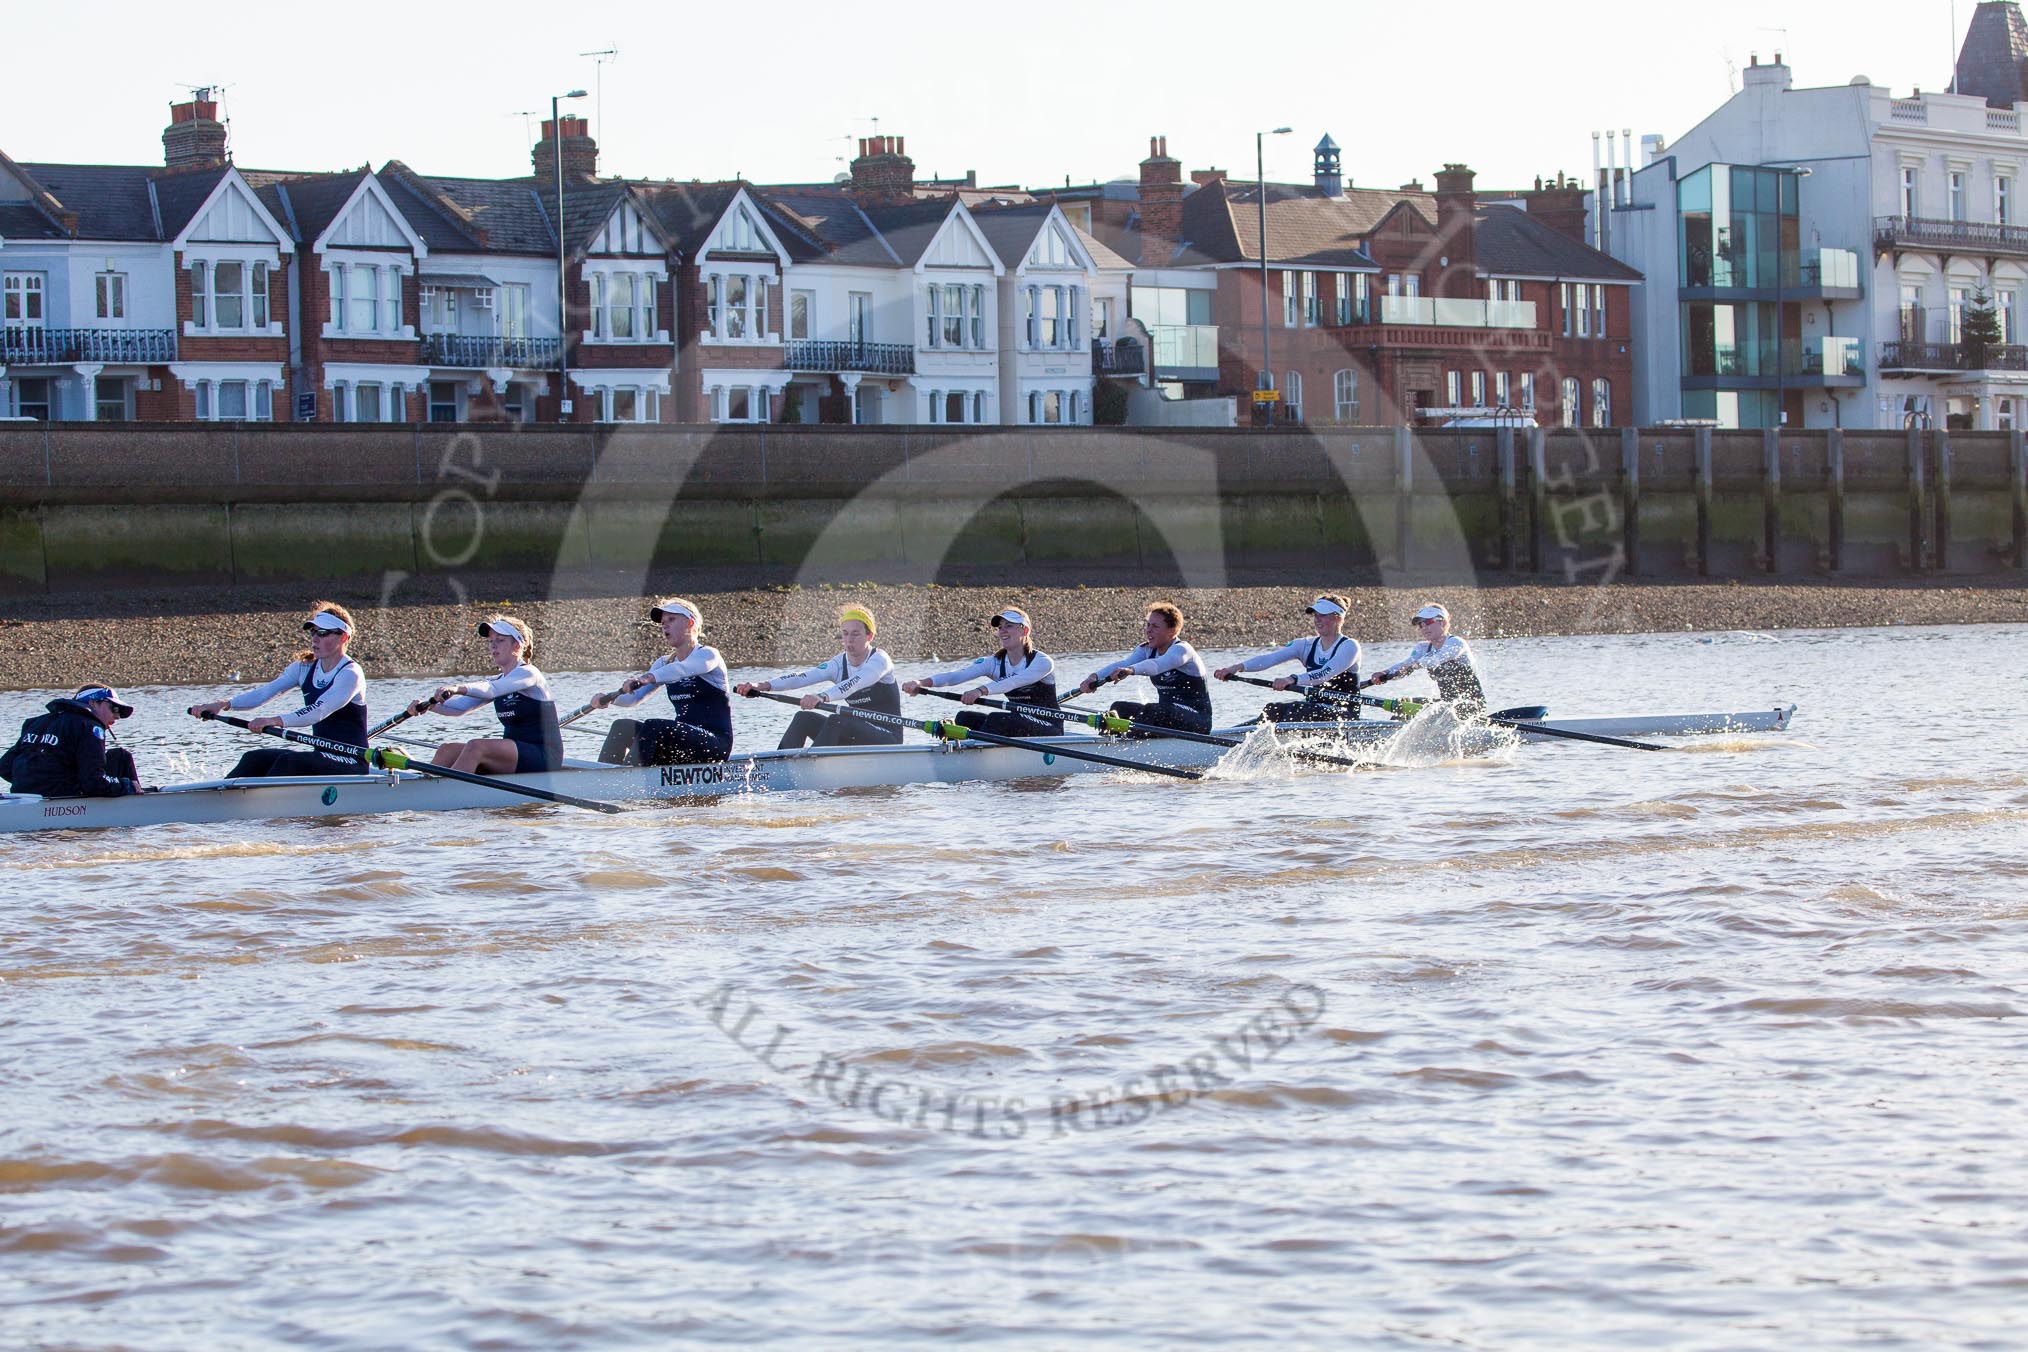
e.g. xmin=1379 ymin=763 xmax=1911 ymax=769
xmin=0 ymin=0 xmax=1975 ymax=189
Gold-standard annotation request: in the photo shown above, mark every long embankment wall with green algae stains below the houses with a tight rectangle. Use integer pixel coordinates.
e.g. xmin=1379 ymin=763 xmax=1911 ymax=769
xmin=0 ymin=424 xmax=2028 ymax=592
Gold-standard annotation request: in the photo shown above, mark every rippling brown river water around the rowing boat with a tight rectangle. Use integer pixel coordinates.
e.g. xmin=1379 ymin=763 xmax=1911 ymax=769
xmin=0 ymin=626 xmax=2028 ymax=1350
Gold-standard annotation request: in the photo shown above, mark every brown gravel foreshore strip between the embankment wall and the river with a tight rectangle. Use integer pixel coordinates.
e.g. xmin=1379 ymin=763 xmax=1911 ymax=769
xmin=0 ymin=574 xmax=2028 ymax=689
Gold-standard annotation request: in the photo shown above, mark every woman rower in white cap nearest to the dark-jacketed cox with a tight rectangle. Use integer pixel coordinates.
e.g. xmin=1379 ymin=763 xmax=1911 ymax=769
xmin=191 ymin=600 xmax=367 ymax=778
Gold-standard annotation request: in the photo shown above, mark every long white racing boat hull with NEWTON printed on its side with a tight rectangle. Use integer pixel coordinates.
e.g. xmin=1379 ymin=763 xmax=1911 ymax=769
xmin=0 ymin=705 xmax=1795 ymax=831
